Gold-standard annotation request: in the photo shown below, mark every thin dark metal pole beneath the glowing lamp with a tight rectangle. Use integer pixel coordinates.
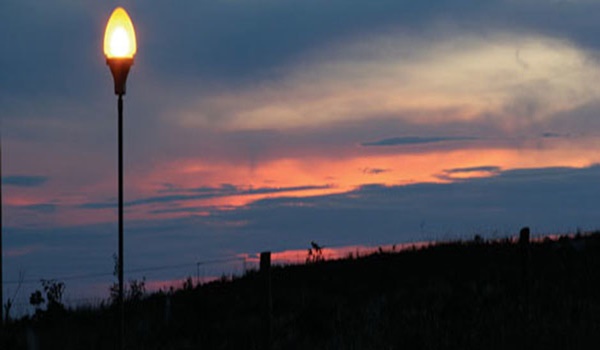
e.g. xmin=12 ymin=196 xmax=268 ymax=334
xmin=118 ymin=94 xmax=125 ymax=349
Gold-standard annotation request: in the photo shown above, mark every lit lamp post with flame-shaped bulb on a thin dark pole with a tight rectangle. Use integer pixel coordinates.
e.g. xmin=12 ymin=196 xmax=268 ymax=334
xmin=104 ymin=7 xmax=137 ymax=349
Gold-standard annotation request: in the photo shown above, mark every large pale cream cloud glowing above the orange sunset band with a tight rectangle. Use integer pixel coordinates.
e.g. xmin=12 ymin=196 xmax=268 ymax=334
xmin=168 ymin=31 xmax=600 ymax=137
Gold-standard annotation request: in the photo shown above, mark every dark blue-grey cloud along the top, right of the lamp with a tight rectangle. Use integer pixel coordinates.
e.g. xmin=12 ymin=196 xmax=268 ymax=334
xmin=107 ymin=0 xmax=599 ymax=85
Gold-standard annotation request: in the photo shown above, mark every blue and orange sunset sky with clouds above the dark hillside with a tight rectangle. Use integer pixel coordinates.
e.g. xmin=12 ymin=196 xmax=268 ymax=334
xmin=0 ymin=0 xmax=600 ymax=310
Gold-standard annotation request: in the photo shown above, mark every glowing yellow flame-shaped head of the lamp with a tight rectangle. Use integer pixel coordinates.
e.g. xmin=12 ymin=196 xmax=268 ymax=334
xmin=104 ymin=7 xmax=137 ymax=59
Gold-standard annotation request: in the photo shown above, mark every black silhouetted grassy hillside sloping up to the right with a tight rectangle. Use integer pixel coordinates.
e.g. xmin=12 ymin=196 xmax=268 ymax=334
xmin=1 ymin=233 xmax=600 ymax=350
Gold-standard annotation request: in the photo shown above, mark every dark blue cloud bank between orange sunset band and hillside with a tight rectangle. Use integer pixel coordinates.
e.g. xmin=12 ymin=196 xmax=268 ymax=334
xmin=213 ymin=166 xmax=600 ymax=249
